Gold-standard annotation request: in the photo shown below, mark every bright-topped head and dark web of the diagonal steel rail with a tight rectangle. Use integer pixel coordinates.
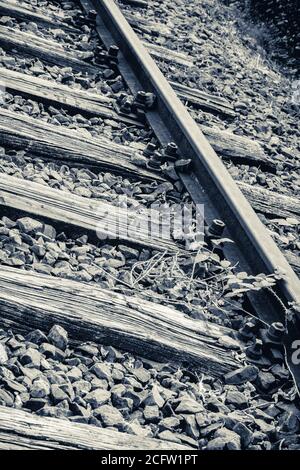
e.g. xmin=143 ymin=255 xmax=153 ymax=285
xmin=92 ymin=0 xmax=300 ymax=303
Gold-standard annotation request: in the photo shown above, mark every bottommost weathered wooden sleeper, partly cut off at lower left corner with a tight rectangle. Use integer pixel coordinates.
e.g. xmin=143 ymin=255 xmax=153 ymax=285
xmin=0 ymin=406 xmax=190 ymax=451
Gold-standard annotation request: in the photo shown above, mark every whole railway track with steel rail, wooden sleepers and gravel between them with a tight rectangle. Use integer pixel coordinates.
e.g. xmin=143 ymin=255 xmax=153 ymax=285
xmin=0 ymin=0 xmax=300 ymax=449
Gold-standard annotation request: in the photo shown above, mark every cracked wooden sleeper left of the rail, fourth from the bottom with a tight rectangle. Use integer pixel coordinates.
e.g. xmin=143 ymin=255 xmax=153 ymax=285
xmin=0 ymin=108 xmax=165 ymax=181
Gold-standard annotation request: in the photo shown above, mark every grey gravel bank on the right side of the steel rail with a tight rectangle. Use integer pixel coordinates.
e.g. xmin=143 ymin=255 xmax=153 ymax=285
xmin=119 ymin=0 xmax=300 ymax=276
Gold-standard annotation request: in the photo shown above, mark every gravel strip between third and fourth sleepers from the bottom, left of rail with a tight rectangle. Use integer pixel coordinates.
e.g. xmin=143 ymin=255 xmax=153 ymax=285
xmin=0 ymin=147 xmax=191 ymax=207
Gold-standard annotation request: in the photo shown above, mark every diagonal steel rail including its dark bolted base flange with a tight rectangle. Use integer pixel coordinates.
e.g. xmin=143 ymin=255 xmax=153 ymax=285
xmin=89 ymin=0 xmax=300 ymax=394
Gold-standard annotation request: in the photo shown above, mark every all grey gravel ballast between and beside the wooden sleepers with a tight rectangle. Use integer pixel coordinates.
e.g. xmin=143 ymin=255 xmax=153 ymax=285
xmin=0 ymin=0 xmax=300 ymax=450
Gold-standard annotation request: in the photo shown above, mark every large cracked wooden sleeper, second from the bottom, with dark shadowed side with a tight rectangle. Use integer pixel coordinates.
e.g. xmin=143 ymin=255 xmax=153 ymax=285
xmin=0 ymin=266 xmax=239 ymax=377
